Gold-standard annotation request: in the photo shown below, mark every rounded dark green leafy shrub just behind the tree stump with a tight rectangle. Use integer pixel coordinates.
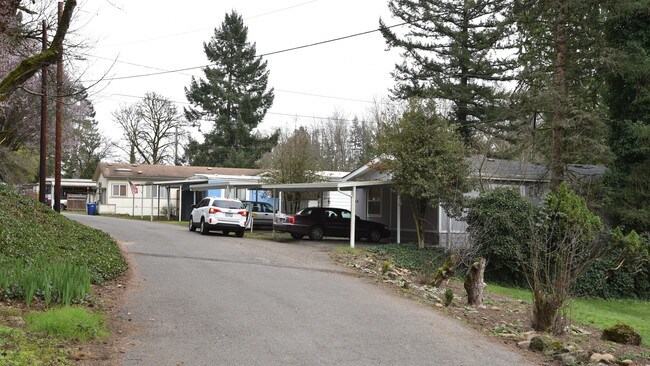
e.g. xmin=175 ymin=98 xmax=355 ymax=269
xmin=467 ymin=188 xmax=535 ymax=285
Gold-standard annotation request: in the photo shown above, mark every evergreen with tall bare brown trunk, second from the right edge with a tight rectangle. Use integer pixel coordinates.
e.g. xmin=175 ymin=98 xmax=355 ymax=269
xmin=514 ymin=0 xmax=608 ymax=189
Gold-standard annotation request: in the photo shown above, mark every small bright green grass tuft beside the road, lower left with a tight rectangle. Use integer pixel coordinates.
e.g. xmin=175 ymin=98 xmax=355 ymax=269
xmin=25 ymin=306 xmax=109 ymax=341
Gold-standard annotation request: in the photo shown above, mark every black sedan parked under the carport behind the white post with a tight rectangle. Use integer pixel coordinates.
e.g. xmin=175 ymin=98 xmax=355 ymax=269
xmin=274 ymin=207 xmax=390 ymax=242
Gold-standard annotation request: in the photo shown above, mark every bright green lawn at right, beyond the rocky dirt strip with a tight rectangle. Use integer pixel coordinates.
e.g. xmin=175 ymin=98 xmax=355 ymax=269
xmin=487 ymin=284 xmax=650 ymax=345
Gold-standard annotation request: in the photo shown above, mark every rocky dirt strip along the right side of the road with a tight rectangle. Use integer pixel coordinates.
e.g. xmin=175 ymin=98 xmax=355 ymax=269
xmin=331 ymin=252 xmax=650 ymax=365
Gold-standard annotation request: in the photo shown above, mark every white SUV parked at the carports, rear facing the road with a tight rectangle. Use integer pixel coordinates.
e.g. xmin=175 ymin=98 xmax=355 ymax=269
xmin=189 ymin=197 xmax=250 ymax=238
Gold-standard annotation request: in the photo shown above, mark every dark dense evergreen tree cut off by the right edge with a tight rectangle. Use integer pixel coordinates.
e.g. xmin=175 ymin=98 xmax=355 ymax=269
xmin=605 ymin=0 xmax=650 ymax=232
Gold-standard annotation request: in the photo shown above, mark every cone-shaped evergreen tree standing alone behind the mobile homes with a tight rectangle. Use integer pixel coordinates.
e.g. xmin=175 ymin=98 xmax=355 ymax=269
xmin=185 ymin=11 xmax=278 ymax=167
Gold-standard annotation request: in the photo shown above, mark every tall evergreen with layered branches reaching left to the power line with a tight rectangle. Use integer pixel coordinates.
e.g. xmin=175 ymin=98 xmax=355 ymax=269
xmin=380 ymin=0 xmax=515 ymax=144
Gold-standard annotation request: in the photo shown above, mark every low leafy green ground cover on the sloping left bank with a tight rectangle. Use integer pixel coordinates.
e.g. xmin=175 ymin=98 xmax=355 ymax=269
xmin=0 ymin=185 xmax=126 ymax=283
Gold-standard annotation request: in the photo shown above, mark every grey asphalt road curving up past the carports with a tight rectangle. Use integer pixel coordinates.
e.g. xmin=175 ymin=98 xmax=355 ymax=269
xmin=68 ymin=215 xmax=525 ymax=366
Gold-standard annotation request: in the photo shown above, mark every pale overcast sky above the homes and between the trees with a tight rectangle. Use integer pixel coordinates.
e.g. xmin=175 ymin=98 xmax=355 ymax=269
xmin=75 ymin=0 xmax=398 ymax=146
